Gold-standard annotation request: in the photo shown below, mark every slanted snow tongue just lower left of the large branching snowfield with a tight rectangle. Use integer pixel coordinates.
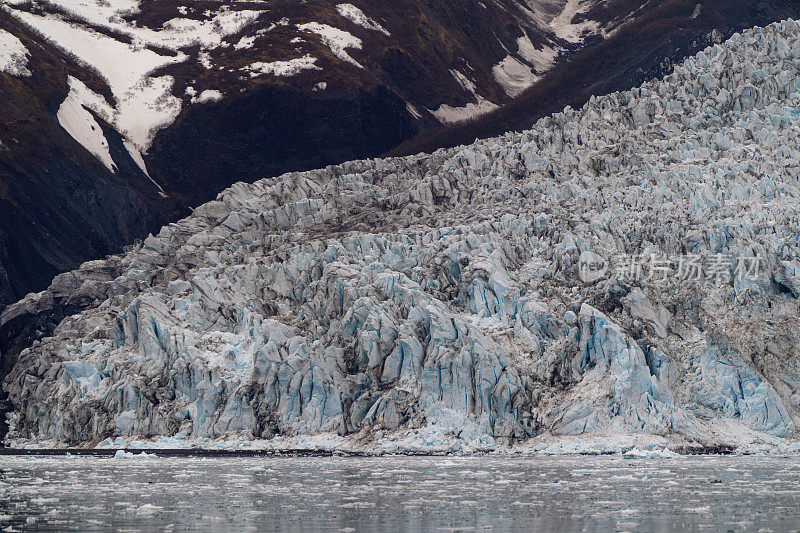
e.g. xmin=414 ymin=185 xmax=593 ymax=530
xmin=56 ymin=76 xmax=117 ymax=172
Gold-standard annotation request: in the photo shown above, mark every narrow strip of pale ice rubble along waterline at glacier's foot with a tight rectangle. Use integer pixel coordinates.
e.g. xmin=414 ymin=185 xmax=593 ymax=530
xmin=6 ymin=427 xmax=800 ymax=459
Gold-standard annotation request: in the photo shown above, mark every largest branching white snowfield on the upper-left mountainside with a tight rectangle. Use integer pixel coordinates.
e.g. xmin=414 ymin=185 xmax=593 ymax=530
xmin=0 ymin=0 xmax=263 ymax=169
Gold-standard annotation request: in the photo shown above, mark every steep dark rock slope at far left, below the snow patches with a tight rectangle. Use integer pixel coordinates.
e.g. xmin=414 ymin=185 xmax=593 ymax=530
xmin=0 ymin=10 xmax=177 ymax=309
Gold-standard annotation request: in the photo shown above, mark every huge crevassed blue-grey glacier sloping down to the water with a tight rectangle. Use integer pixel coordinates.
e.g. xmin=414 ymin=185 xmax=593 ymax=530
xmin=0 ymin=21 xmax=800 ymax=447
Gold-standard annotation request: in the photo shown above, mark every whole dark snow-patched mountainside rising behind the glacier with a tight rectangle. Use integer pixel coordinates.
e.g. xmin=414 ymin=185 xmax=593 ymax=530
xmin=0 ymin=0 xmax=797 ymax=309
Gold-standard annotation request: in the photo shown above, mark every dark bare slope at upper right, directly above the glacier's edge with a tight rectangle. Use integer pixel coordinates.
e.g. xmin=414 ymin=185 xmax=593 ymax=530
xmin=388 ymin=0 xmax=800 ymax=155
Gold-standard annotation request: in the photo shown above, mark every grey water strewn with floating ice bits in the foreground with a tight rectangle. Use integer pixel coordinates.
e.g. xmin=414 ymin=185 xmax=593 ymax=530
xmin=0 ymin=456 xmax=800 ymax=531
